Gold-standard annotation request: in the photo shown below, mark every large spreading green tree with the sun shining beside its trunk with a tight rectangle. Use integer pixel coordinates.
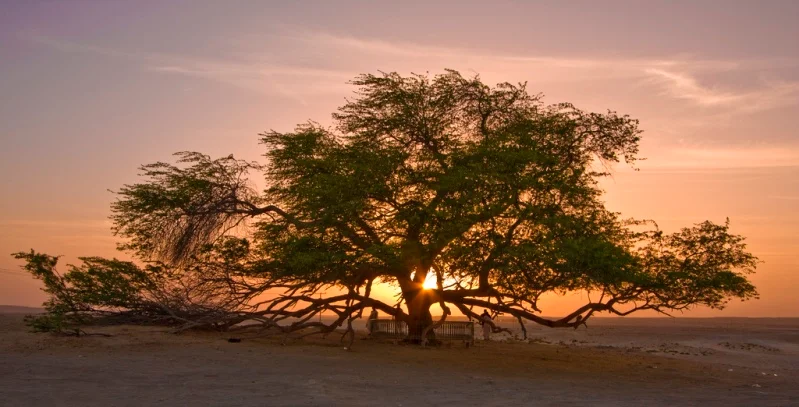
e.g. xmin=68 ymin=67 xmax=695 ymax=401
xmin=17 ymin=71 xmax=757 ymax=344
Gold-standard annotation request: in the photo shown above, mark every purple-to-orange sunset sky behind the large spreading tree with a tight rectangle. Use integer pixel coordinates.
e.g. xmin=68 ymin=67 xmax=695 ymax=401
xmin=0 ymin=0 xmax=799 ymax=317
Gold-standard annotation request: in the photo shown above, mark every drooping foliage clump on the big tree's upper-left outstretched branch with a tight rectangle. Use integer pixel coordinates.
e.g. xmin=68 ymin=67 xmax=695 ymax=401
xmin=111 ymin=152 xmax=259 ymax=263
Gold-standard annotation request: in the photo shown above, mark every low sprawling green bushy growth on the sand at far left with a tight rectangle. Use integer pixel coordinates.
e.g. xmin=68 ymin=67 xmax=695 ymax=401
xmin=14 ymin=250 xmax=247 ymax=336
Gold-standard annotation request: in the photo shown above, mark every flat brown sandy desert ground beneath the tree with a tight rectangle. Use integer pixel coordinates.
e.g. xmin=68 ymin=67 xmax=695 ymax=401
xmin=0 ymin=312 xmax=799 ymax=406
